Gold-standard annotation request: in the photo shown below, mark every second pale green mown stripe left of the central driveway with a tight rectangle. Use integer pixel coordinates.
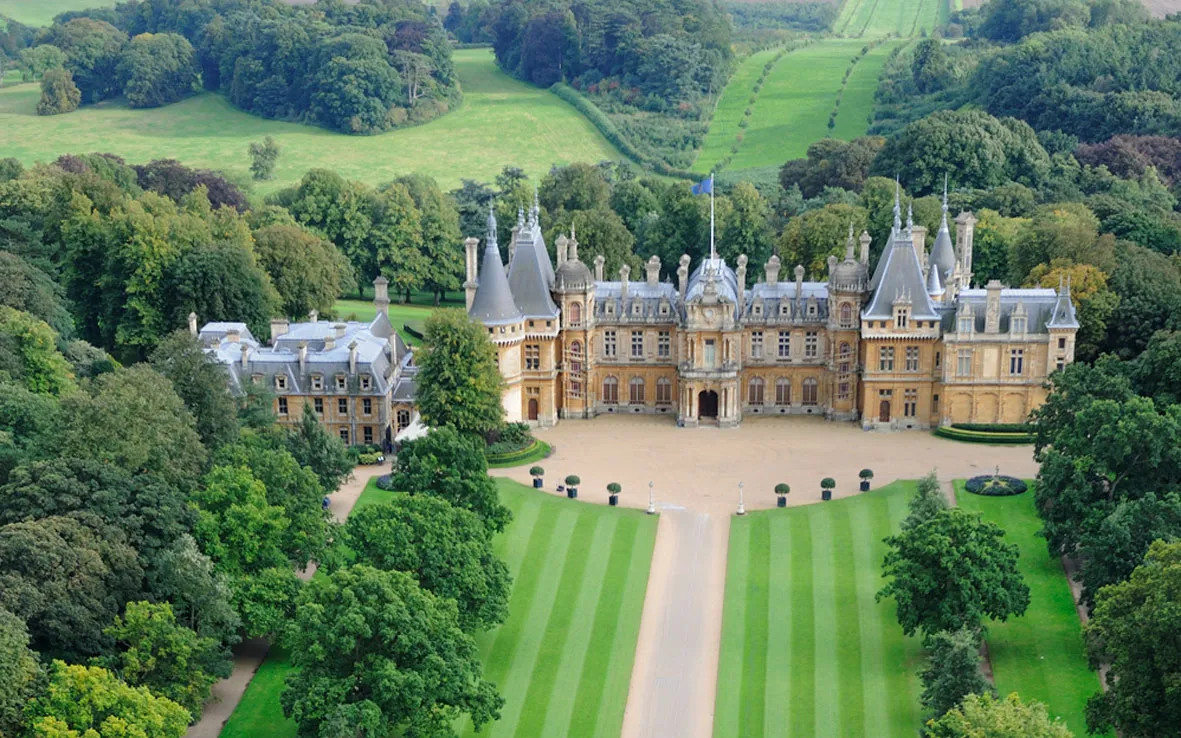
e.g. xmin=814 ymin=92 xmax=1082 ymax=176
xmin=541 ymin=515 xmax=619 ymax=736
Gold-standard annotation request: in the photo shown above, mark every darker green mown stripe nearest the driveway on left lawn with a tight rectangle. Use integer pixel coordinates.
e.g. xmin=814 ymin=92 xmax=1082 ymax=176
xmin=567 ymin=517 xmax=638 ymax=738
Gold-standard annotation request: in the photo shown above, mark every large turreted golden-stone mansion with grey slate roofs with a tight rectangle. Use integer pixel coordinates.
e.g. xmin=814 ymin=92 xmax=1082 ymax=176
xmin=464 ymin=191 xmax=1078 ymax=429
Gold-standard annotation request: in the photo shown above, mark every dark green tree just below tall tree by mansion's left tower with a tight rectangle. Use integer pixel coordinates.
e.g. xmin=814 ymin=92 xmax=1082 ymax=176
xmin=393 ymin=426 xmax=513 ymax=533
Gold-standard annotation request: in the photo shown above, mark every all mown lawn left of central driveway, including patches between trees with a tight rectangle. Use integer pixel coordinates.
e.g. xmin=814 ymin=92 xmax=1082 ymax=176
xmin=221 ymin=479 xmax=657 ymax=738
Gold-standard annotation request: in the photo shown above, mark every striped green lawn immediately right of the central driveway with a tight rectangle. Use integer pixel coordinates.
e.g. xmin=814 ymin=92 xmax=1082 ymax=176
xmin=713 ymin=482 xmax=921 ymax=738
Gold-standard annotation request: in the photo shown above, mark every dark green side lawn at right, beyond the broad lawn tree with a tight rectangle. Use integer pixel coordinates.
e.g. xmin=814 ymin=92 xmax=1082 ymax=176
xmin=955 ymin=482 xmax=1100 ymax=736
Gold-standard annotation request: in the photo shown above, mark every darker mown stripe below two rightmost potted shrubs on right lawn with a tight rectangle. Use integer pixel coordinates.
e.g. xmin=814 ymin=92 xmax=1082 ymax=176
xmin=822 ymin=501 xmax=866 ymax=737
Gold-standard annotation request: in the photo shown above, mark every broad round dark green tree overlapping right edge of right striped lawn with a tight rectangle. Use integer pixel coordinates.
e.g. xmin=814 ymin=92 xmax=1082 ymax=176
xmin=877 ymin=508 xmax=1030 ymax=635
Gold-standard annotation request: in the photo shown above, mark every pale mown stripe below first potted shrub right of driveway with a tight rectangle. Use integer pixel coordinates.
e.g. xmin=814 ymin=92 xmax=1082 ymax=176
xmin=763 ymin=515 xmax=798 ymax=738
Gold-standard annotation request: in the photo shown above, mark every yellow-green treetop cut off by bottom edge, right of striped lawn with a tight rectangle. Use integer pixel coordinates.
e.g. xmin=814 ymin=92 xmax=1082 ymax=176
xmin=927 ymin=693 xmax=1074 ymax=738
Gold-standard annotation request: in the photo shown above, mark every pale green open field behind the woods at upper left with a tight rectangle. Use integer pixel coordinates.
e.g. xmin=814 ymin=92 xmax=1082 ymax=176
xmin=0 ymin=50 xmax=621 ymax=195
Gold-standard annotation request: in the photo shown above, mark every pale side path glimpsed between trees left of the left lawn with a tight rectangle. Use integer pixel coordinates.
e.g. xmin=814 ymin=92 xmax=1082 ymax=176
xmin=185 ymin=462 xmax=390 ymax=738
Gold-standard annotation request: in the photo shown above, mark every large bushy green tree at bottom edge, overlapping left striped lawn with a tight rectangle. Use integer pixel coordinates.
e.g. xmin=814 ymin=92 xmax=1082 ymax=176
xmin=281 ymin=566 xmax=504 ymax=737
